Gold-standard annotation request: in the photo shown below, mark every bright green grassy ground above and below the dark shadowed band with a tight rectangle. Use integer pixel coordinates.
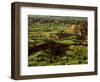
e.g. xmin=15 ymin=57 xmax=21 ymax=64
xmin=28 ymin=24 xmax=87 ymax=66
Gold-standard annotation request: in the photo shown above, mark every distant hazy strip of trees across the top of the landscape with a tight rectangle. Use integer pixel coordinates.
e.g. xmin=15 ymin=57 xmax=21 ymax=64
xmin=28 ymin=15 xmax=87 ymax=25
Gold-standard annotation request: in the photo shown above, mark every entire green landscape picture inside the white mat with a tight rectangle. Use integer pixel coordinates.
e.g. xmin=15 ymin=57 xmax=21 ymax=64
xmin=28 ymin=15 xmax=88 ymax=66
